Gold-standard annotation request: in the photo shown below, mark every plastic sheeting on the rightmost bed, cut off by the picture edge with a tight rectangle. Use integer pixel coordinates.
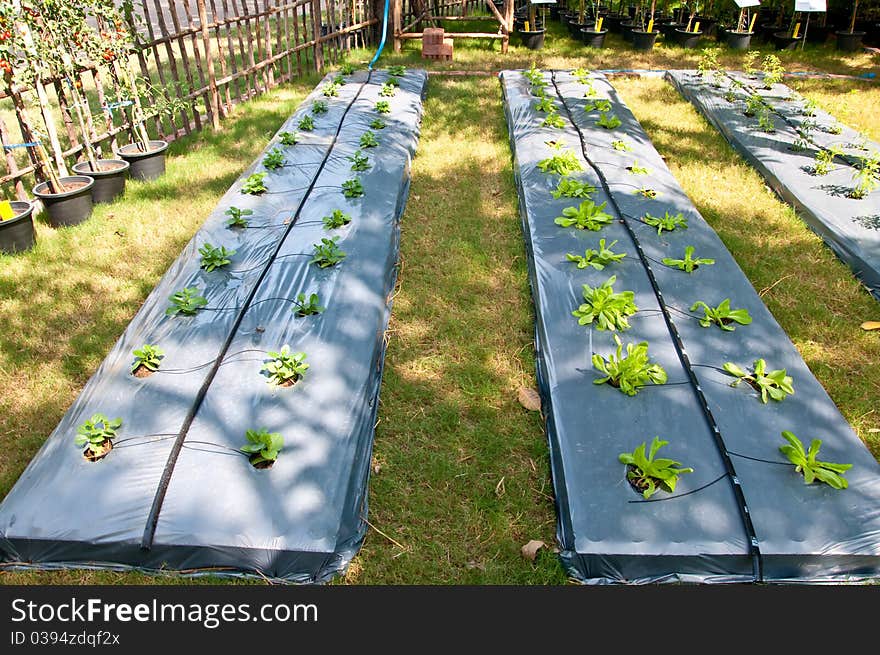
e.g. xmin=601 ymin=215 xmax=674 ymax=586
xmin=667 ymin=71 xmax=880 ymax=300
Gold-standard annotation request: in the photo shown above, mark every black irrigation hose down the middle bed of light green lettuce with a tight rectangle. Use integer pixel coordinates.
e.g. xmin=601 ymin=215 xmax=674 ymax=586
xmin=550 ymin=72 xmax=764 ymax=582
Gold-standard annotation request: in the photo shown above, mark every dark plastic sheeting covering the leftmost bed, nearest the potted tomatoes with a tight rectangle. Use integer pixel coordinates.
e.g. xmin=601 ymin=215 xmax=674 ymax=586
xmin=0 ymin=70 xmax=427 ymax=582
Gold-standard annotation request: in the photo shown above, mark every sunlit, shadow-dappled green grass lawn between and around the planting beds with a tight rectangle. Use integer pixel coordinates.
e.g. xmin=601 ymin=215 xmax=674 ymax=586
xmin=0 ymin=19 xmax=880 ymax=584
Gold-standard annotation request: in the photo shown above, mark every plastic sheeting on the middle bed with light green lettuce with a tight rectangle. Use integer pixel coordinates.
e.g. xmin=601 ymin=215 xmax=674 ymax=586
xmin=501 ymin=71 xmax=880 ymax=584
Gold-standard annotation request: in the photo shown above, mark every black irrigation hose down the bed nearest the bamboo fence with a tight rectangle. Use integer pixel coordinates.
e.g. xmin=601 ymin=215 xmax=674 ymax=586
xmin=141 ymin=71 xmax=373 ymax=550
